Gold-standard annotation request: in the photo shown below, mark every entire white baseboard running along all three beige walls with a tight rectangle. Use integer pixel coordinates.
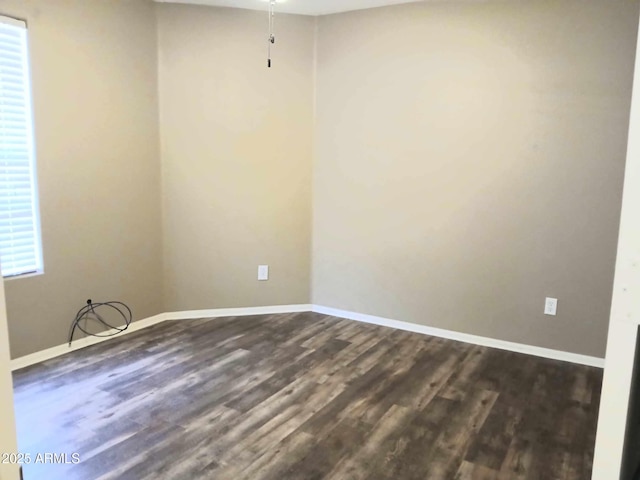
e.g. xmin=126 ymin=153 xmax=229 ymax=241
xmin=11 ymin=304 xmax=604 ymax=370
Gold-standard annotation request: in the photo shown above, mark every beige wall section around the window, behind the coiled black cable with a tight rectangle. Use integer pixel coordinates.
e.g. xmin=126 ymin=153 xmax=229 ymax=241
xmin=0 ymin=0 xmax=164 ymax=357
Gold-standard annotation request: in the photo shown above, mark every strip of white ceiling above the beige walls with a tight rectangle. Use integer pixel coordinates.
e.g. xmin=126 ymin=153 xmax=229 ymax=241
xmin=156 ymin=0 xmax=422 ymax=15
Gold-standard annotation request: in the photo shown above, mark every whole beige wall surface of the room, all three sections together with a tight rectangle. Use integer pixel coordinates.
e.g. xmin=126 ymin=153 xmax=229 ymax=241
xmin=0 ymin=0 xmax=638 ymax=357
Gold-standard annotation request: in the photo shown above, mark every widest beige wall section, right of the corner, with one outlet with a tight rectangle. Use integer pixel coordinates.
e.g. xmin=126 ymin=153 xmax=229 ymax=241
xmin=313 ymin=0 xmax=638 ymax=356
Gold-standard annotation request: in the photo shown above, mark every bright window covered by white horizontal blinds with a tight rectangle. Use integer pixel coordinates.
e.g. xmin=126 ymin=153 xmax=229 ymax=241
xmin=0 ymin=16 xmax=42 ymax=277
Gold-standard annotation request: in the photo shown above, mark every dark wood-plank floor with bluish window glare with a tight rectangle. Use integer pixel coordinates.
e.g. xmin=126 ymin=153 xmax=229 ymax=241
xmin=14 ymin=313 xmax=602 ymax=480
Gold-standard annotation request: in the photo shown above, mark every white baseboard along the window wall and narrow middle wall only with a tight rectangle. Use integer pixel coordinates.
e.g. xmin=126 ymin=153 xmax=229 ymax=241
xmin=11 ymin=305 xmax=311 ymax=371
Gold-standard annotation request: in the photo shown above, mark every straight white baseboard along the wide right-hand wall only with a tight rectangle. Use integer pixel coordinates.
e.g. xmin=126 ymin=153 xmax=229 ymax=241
xmin=311 ymin=305 xmax=604 ymax=368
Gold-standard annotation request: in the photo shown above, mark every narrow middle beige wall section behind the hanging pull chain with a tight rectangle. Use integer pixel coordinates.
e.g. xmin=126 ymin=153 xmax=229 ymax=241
xmin=158 ymin=5 xmax=314 ymax=311
